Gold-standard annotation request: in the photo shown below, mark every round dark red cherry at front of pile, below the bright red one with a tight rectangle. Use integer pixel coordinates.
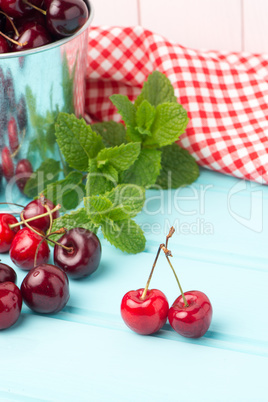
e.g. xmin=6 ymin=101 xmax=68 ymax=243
xmin=21 ymin=264 xmax=70 ymax=314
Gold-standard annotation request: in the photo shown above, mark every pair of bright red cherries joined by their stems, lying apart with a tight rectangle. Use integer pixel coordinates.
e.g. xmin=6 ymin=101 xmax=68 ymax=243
xmin=121 ymin=227 xmax=212 ymax=338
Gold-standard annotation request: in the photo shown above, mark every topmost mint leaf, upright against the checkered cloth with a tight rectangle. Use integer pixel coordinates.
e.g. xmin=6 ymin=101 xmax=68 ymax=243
xmin=135 ymin=71 xmax=177 ymax=107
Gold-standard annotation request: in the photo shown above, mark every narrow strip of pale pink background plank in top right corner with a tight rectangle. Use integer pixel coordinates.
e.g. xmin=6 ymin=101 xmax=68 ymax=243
xmin=243 ymin=0 xmax=268 ymax=53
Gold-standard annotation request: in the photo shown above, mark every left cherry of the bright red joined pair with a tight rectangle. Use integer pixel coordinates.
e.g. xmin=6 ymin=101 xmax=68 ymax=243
xmin=121 ymin=289 xmax=169 ymax=335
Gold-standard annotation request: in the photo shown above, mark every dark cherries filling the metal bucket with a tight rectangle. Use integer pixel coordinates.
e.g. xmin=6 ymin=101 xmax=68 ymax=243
xmin=0 ymin=0 xmax=90 ymax=53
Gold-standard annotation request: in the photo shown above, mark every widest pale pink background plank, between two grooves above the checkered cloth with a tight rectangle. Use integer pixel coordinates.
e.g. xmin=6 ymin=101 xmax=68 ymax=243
xmin=140 ymin=0 xmax=242 ymax=51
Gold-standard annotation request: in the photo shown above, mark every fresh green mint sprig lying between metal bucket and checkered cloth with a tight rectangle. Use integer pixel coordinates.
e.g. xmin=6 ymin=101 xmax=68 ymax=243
xmin=36 ymin=71 xmax=199 ymax=253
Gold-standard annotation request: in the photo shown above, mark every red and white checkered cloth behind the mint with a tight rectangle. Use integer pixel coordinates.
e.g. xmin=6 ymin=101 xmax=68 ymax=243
xmin=86 ymin=27 xmax=268 ymax=184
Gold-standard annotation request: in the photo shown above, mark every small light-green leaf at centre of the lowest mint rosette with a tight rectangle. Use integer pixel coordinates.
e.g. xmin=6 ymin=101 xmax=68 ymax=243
xmin=84 ymin=195 xmax=113 ymax=225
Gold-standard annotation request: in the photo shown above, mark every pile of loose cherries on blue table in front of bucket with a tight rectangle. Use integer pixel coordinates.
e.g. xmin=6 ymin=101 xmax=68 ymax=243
xmin=0 ymin=196 xmax=101 ymax=329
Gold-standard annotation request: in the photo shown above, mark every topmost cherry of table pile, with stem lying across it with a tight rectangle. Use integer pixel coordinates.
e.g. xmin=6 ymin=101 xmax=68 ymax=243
xmin=22 ymin=197 xmax=59 ymax=232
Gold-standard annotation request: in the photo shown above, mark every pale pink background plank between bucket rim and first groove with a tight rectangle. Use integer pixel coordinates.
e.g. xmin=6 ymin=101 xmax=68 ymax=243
xmin=92 ymin=0 xmax=138 ymax=26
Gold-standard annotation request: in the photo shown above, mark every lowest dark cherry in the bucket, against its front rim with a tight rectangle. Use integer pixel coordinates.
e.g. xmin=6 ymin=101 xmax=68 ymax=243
xmin=12 ymin=21 xmax=52 ymax=52
